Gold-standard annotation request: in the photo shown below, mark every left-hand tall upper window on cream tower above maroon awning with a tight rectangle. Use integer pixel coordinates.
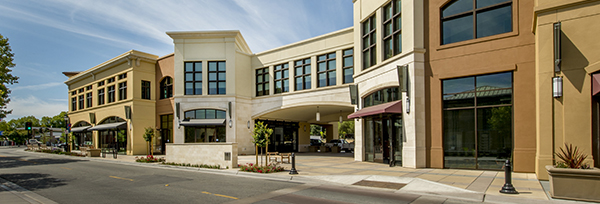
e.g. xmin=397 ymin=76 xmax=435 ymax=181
xmin=362 ymin=15 xmax=377 ymax=69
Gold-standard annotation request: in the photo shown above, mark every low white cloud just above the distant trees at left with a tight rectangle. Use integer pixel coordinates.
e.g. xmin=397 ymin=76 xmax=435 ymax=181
xmin=5 ymin=95 xmax=68 ymax=120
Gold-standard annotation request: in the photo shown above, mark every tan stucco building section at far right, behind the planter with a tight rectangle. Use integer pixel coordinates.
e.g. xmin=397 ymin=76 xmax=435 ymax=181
xmin=533 ymin=0 xmax=600 ymax=179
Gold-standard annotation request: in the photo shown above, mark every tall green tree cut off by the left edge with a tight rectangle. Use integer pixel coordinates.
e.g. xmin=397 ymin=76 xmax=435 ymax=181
xmin=0 ymin=34 xmax=19 ymax=118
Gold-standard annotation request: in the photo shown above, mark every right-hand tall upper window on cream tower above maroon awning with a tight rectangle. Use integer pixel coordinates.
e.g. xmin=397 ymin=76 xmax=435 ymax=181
xmin=383 ymin=0 xmax=402 ymax=60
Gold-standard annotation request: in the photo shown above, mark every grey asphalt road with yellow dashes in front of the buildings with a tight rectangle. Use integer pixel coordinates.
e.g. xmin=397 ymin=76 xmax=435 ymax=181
xmin=0 ymin=148 xmax=432 ymax=204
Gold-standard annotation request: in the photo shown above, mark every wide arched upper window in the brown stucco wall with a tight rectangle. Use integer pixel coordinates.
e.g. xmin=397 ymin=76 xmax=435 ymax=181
xmin=441 ymin=0 xmax=512 ymax=44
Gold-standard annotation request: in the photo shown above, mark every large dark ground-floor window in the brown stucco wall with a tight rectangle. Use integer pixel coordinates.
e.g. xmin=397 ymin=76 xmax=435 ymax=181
xmin=442 ymin=72 xmax=513 ymax=170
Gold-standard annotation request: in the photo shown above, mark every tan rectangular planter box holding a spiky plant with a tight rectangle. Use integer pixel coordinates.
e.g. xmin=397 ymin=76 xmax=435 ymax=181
xmin=546 ymin=165 xmax=600 ymax=202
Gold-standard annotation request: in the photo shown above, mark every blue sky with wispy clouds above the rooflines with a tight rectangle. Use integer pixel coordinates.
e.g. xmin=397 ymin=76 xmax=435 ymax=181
xmin=0 ymin=0 xmax=353 ymax=120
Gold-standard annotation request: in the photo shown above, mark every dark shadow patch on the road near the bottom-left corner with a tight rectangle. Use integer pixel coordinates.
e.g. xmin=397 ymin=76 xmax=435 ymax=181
xmin=0 ymin=173 xmax=66 ymax=191
